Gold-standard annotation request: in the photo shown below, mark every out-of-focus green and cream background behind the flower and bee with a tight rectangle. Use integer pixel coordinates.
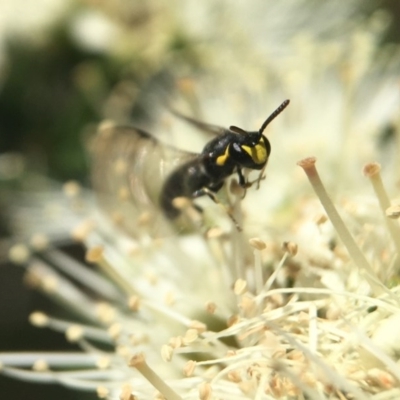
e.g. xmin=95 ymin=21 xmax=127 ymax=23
xmin=0 ymin=0 xmax=400 ymax=399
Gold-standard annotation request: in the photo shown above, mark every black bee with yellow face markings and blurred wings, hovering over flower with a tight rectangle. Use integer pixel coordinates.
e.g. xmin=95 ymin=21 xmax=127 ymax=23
xmin=91 ymin=100 xmax=289 ymax=233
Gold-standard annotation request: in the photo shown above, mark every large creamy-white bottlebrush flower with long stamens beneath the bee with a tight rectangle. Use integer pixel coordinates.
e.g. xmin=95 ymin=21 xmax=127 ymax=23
xmin=0 ymin=1 xmax=400 ymax=400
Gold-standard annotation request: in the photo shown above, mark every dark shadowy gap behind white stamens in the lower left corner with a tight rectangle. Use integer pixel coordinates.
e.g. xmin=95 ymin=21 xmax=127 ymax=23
xmin=0 ymin=245 xmax=98 ymax=400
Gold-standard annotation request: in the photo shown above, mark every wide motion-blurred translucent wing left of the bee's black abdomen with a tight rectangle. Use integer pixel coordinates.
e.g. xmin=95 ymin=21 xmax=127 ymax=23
xmin=90 ymin=123 xmax=197 ymax=237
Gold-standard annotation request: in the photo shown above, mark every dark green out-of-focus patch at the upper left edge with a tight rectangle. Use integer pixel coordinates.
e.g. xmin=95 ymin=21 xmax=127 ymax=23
xmin=0 ymin=27 xmax=99 ymax=183
